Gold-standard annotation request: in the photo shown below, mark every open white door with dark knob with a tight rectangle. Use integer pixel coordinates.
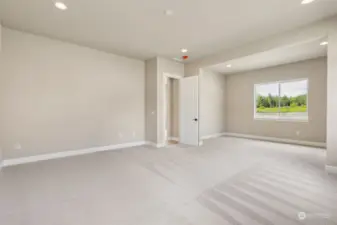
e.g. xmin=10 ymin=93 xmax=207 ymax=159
xmin=179 ymin=76 xmax=199 ymax=146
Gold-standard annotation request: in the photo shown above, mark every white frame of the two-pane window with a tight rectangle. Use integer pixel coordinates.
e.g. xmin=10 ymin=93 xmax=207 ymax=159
xmin=254 ymin=78 xmax=309 ymax=122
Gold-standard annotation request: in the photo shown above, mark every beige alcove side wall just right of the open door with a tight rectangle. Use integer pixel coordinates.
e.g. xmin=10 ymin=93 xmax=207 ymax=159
xmin=199 ymin=69 xmax=226 ymax=137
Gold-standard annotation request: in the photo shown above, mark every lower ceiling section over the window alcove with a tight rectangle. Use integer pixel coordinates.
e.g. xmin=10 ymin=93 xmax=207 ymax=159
xmin=208 ymin=40 xmax=327 ymax=74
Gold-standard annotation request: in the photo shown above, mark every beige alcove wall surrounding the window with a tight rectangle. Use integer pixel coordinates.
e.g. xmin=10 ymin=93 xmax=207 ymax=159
xmin=226 ymin=58 xmax=327 ymax=142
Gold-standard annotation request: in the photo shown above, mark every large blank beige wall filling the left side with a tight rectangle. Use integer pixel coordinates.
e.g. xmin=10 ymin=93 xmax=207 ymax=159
xmin=0 ymin=28 xmax=145 ymax=159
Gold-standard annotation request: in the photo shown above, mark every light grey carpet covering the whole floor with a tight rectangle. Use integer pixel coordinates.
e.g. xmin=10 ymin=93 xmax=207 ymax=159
xmin=0 ymin=138 xmax=337 ymax=225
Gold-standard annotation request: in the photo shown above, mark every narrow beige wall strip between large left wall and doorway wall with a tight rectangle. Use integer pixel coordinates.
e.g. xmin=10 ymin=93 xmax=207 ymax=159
xmin=145 ymin=58 xmax=158 ymax=143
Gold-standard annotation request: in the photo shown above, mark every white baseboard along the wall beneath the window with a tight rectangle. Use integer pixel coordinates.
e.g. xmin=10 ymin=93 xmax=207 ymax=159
xmin=224 ymin=133 xmax=326 ymax=148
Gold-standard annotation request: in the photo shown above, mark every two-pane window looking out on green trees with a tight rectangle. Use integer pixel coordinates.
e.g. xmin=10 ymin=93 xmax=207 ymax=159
xmin=254 ymin=79 xmax=308 ymax=121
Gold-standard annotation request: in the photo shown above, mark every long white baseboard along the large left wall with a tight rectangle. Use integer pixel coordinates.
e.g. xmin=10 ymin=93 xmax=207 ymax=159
xmin=3 ymin=141 xmax=147 ymax=167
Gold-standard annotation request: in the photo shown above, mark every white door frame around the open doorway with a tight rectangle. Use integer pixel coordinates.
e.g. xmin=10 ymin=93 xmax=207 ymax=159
xmin=161 ymin=73 xmax=184 ymax=146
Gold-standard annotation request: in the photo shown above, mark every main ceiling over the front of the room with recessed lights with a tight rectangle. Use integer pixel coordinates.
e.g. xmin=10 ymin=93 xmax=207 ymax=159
xmin=0 ymin=0 xmax=337 ymax=61
